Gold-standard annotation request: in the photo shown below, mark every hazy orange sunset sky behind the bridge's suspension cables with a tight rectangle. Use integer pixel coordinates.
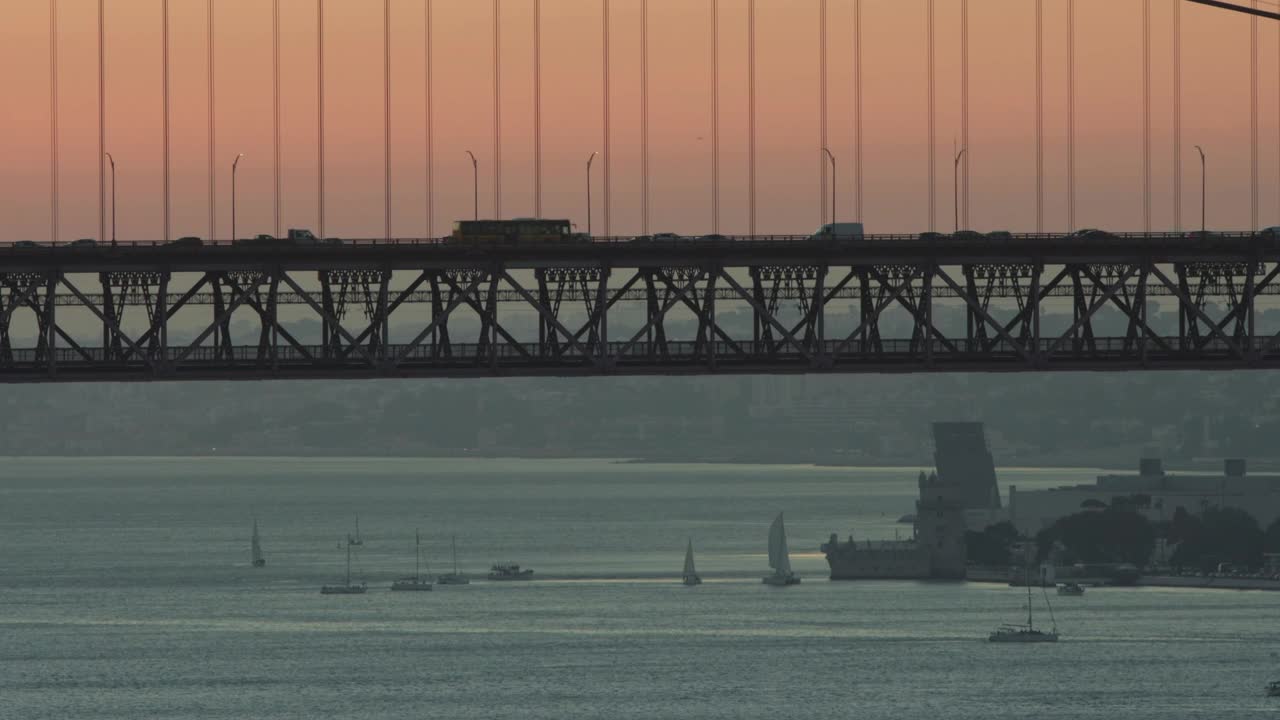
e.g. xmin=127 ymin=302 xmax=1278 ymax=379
xmin=0 ymin=0 xmax=1280 ymax=240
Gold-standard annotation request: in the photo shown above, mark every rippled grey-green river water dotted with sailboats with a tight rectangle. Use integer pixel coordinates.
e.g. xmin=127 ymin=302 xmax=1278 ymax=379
xmin=0 ymin=457 xmax=1280 ymax=720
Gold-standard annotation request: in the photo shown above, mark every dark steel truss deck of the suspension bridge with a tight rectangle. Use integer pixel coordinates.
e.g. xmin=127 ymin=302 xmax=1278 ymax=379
xmin=0 ymin=234 xmax=1280 ymax=382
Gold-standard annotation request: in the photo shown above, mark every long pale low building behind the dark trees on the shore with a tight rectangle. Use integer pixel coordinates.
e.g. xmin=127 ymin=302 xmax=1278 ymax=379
xmin=1009 ymin=457 xmax=1280 ymax=534
